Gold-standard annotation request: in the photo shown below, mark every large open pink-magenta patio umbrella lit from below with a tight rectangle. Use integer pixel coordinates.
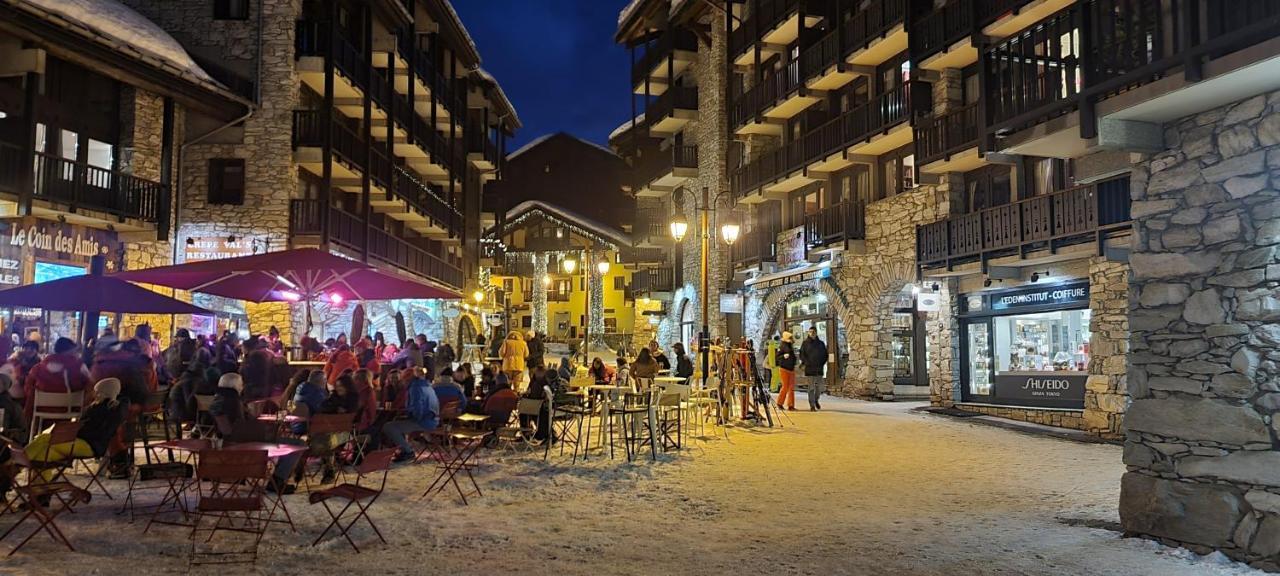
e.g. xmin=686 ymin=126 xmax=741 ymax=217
xmin=114 ymin=248 xmax=461 ymax=329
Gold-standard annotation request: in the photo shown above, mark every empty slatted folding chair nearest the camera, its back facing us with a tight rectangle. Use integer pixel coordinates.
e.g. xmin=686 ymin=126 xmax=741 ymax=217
xmin=188 ymin=449 xmax=271 ymax=566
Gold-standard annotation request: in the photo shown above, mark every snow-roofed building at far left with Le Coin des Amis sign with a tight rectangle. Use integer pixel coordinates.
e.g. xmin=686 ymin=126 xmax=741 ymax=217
xmin=0 ymin=0 xmax=252 ymax=342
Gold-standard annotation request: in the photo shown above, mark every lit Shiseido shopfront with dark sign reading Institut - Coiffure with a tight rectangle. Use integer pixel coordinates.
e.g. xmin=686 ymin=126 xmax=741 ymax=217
xmin=961 ymin=284 xmax=1092 ymax=408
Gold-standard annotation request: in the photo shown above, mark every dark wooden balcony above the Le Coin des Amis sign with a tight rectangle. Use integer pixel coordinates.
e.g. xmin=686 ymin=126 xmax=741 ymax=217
xmin=0 ymin=142 xmax=170 ymax=230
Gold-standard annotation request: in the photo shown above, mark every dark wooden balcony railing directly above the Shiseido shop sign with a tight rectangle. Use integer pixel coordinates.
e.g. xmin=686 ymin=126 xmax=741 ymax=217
xmin=915 ymin=177 xmax=1130 ymax=265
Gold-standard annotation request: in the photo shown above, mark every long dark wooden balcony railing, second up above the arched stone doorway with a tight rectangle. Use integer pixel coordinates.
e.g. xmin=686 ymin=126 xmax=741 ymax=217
xmin=730 ymin=81 xmax=929 ymax=198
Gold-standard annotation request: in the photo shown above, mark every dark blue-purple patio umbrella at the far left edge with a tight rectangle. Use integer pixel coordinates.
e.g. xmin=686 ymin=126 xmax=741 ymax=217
xmin=0 ymin=274 xmax=214 ymax=316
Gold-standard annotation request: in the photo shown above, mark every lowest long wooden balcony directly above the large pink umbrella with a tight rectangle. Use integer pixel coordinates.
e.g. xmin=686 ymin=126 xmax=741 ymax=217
xmin=289 ymin=200 xmax=463 ymax=289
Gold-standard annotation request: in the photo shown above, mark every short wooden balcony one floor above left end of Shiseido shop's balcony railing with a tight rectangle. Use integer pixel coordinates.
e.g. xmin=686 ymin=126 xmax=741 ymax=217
xmin=915 ymin=102 xmax=983 ymax=173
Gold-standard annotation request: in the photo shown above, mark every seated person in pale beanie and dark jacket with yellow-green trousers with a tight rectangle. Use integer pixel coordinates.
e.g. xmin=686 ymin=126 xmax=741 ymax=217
xmin=26 ymin=378 xmax=129 ymax=481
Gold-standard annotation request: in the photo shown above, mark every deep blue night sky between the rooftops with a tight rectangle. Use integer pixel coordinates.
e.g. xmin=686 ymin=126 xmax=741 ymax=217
xmin=453 ymin=0 xmax=631 ymax=151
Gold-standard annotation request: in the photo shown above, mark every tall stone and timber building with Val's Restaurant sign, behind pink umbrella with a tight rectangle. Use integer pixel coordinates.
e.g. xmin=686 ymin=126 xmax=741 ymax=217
xmin=124 ymin=0 xmax=520 ymax=339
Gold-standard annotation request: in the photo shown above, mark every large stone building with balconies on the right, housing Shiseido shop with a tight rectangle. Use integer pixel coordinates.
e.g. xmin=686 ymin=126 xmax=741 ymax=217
xmin=618 ymin=0 xmax=1280 ymax=568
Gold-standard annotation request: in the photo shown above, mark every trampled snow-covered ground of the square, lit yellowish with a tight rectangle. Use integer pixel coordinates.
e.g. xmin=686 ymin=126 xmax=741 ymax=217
xmin=0 ymin=398 xmax=1261 ymax=576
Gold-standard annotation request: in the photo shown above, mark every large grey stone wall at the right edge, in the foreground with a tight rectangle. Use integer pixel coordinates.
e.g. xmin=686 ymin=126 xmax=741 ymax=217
xmin=1120 ymin=92 xmax=1280 ymax=570
